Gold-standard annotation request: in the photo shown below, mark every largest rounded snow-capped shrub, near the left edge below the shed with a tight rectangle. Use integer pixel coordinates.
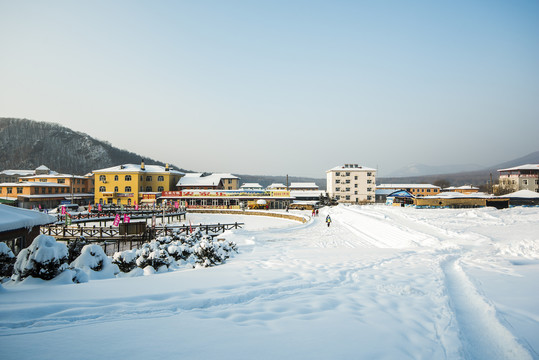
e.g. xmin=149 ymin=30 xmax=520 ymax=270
xmin=12 ymin=235 xmax=68 ymax=281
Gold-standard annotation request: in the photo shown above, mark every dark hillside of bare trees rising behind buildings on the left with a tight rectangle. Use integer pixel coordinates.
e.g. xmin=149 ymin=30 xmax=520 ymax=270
xmin=0 ymin=118 xmax=186 ymax=174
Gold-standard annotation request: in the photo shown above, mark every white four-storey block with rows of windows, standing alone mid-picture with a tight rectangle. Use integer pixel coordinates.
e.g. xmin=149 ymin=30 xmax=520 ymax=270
xmin=326 ymin=164 xmax=376 ymax=204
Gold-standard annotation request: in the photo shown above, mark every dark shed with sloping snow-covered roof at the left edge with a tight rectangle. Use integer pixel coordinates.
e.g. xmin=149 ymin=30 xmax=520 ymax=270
xmin=0 ymin=204 xmax=56 ymax=255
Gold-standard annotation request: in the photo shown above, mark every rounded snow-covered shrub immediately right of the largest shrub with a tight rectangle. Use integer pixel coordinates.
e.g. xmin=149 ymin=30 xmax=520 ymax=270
xmin=71 ymin=244 xmax=120 ymax=279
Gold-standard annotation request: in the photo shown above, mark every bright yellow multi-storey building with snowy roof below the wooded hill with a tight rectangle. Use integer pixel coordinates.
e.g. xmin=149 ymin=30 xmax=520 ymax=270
xmin=93 ymin=162 xmax=184 ymax=205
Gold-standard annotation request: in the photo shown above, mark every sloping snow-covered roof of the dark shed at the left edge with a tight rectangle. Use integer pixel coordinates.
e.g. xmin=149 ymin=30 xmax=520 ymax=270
xmin=0 ymin=204 xmax=56 ymax=232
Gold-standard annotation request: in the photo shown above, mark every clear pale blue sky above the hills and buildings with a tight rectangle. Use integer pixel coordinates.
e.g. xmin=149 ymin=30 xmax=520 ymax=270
xmin=0 ymin=0 xmax=539 ymax=177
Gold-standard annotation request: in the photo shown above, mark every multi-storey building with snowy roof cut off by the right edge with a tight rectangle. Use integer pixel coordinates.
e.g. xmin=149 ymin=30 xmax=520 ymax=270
xmin=497 ymin=164 xmax=539 ymax=192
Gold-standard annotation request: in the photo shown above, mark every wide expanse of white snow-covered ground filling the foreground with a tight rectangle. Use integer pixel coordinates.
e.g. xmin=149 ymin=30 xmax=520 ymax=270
xmin=0 ymin=206 xmax=539 ymax=359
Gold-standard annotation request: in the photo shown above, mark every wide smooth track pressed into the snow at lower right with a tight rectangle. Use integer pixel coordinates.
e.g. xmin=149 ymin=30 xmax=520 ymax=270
xmin=441 ymin=256 xmax=532 ymax=359
